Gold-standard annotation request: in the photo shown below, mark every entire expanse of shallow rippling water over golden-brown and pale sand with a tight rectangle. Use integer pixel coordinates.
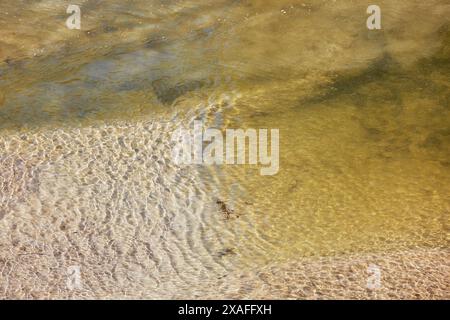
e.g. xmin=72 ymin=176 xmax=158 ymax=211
xmin=0 ymin=0 xmax=450 ymax=299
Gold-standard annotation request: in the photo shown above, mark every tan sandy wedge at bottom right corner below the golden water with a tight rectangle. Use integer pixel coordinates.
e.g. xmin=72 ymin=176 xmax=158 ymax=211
xmin=230 ymin=249 xmax=450 ymax=299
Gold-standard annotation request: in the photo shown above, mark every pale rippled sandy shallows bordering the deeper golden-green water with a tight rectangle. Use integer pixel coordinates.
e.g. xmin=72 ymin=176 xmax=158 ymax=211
xmin=0 ymin=115 xmax=450 ymax=299
